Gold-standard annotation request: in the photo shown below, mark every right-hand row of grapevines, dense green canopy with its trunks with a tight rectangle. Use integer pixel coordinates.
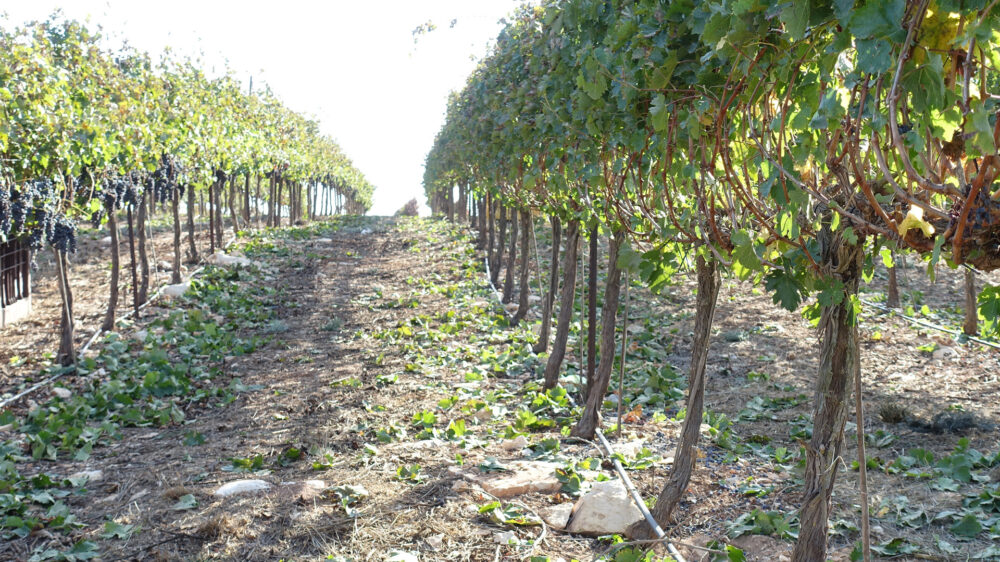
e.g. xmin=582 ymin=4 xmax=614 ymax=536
xmin=424 ymin=0 xmax=1000 ymax=561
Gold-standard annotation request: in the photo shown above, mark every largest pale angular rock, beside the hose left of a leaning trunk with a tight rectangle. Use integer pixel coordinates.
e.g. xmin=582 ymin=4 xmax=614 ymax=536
xmin=566 ymin=480 xmax=642 ymax=536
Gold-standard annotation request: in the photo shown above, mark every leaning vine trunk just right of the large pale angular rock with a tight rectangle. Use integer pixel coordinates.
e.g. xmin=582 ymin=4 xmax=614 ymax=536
xmin=625 ymin=252 xmax=721 ymax=539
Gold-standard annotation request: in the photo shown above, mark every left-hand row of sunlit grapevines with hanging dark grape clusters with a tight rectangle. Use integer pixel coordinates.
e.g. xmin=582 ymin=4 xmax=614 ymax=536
xmin=0 ymin=16 xmax=374 ymax=365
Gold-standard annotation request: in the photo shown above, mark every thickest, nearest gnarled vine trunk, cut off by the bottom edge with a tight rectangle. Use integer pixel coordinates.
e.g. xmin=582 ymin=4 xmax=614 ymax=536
xmin=792 ymin=227 xmax=864 ymax=562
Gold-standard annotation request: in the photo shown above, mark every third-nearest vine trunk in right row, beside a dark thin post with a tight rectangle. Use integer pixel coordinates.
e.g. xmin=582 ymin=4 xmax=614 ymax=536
xmin=572 ymin=233 xmax=622 ymax=439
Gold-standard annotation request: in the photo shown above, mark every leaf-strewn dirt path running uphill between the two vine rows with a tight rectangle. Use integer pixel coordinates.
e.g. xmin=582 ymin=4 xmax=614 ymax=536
xmin=8 ymin=220 xmax=593 ymax=560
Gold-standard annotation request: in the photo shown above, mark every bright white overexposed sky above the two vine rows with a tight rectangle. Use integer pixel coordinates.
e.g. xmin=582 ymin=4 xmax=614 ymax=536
xmin=0 ymin=0 xmax=519 ymax=214
